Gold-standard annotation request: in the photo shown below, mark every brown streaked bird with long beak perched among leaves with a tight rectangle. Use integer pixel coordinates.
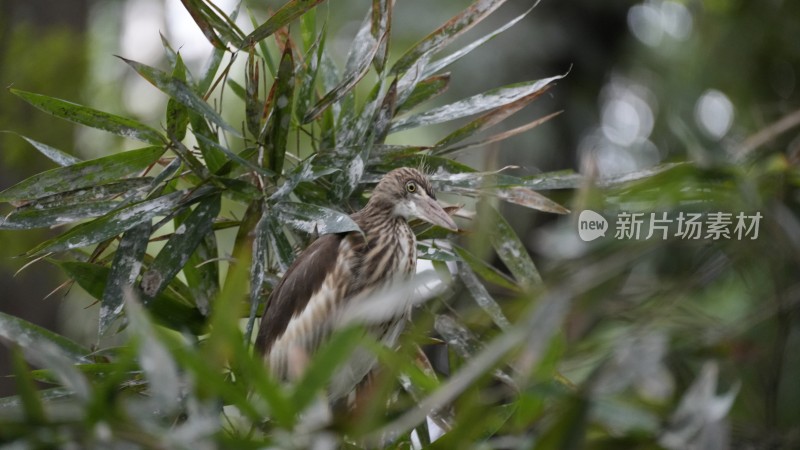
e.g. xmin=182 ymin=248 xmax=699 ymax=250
xmin=255 ymin=167 xmax=458 ymax=401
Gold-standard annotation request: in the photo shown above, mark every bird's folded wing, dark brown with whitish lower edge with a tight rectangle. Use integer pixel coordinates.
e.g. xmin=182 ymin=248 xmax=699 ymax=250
xmin=256 ymin=233 xmax=352 ymax=354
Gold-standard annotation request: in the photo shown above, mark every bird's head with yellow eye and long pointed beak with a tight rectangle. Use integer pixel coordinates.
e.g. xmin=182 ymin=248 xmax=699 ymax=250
xmin=370 ymin=167 xmax=458 ymax=231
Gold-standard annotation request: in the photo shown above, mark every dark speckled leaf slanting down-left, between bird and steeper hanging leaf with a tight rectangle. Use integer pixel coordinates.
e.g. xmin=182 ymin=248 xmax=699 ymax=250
xmin=141 ymin=195 xmax=220 ymax=303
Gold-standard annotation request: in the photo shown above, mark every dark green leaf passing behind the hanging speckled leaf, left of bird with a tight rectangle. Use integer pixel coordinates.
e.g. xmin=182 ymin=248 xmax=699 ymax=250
xmin=56 ymin=261 xmax=205 ymax=333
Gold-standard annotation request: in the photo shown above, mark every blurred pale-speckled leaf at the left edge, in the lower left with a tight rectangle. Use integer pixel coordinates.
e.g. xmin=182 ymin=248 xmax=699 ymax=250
xmin=0 ymin=312 xmax=91 ymax=363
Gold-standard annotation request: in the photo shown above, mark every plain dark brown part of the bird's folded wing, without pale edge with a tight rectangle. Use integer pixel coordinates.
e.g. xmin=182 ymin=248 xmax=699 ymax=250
xmin=256 ymin=233 xmax=346 ymax=354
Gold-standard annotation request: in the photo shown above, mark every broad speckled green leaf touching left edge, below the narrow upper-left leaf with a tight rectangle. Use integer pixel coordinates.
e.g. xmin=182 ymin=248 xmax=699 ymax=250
xmin=0 ymin=147 xmax=164 ymax=202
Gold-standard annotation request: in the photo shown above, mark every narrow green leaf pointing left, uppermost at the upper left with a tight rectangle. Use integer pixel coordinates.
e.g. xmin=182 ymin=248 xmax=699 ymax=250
xmin=9 ymin=89 xmax=164 ymax=145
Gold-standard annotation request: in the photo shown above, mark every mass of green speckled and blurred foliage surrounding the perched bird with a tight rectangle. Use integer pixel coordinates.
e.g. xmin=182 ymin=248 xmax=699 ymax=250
xmin=0 ymin=0 xmax=800 ymax=449
